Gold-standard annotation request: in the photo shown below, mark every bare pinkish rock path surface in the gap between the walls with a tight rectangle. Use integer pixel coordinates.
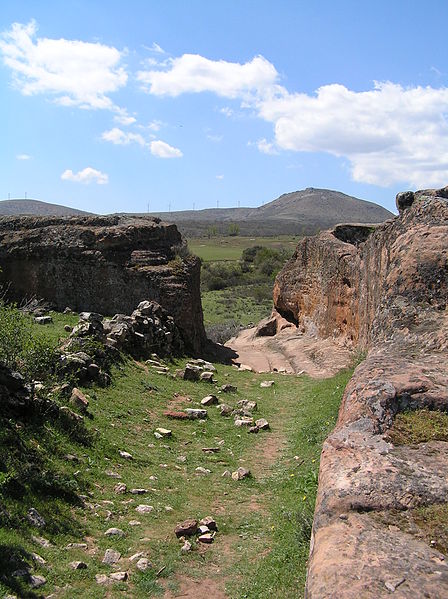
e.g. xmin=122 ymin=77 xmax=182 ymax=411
xmin=226 ymin=327 xmax=352 ymax=378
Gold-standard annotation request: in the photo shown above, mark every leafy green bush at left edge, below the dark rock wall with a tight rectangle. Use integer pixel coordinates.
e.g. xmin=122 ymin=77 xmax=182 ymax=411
xmin=0 ymin=301 xmax=58 ymax=380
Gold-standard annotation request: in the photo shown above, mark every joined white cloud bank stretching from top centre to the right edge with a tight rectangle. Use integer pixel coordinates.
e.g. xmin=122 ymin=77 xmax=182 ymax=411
xmin=138 ymin=54 xmax=448 ymax=187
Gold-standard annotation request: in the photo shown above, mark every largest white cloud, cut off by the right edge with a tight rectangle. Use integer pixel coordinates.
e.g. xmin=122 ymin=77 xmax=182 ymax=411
xmin=257 ymin=82 xmax=448 ymax=187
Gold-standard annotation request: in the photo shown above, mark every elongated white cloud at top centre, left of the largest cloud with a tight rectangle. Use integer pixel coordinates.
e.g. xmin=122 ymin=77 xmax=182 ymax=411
xmin=137 ymin=54 xmax=278 ymax=98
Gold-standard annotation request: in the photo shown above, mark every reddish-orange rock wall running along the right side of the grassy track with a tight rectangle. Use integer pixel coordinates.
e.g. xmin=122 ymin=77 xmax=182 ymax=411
xmin=274 ymin=188 xmax=448 ymax=599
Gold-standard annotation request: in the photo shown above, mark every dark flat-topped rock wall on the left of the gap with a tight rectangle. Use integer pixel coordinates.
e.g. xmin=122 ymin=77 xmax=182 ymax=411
xmin=0 ymin=216 xmax=206 ymax=353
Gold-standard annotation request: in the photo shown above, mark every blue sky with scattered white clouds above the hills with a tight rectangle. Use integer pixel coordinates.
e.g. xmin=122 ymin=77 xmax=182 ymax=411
xmin=0 ymin=0 xmax=448 ymax=213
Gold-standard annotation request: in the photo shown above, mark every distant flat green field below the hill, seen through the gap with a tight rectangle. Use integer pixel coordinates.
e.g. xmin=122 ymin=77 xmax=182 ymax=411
xmin=188 ymin=235 xmax=299 ymax=262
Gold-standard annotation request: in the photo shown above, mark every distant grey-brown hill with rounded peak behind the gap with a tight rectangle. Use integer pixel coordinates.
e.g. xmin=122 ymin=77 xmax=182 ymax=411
xmin=153 ymin=187 xmax=393 ymax=237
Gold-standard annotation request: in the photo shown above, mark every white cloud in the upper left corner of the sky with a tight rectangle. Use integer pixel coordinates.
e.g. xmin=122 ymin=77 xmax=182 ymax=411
xmin=0 ymin=21 xmax=127 ymax=111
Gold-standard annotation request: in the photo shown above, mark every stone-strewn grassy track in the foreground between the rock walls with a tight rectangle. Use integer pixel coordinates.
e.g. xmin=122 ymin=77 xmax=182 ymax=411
xmin=0 ymin=321 xmax=350 ymax=599
